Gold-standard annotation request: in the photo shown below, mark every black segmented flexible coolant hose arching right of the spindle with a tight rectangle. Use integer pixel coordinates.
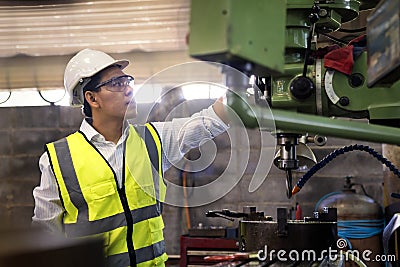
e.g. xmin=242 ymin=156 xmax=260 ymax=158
xmin=296 ymin=144 xmax=400 ymax=192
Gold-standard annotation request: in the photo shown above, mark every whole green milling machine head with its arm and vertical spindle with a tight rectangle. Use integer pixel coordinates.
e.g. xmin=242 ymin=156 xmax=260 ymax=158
xmin=189 ymin=0 xmax=400 ymax=199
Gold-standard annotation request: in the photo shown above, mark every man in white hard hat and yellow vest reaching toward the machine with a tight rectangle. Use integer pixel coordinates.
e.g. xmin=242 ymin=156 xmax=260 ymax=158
xmin=32 ymin=49 xmax=227 ymax=266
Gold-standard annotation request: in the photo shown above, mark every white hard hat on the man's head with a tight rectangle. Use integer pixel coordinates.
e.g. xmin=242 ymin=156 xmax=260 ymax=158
xmin=64 ymin=48 xmax=129 ymax=105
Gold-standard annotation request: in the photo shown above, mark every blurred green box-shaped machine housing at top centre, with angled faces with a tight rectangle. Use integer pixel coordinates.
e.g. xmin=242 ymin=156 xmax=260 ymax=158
xmin=189 ymin=0 xmax=286 ymax=75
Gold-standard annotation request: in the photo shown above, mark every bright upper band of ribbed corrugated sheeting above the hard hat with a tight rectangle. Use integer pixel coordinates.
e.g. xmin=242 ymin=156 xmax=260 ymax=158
xmin=0 ymin=0 xmax=190 ymax=57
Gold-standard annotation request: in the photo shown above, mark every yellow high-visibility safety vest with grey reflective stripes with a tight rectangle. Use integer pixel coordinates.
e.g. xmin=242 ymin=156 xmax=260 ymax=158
xmin=47 ymin=123 xmax=168 ymax=267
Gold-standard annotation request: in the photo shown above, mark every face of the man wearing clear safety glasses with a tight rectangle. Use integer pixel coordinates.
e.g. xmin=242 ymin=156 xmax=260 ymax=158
xmin=96 ymin=67 xmax=136 ymax=119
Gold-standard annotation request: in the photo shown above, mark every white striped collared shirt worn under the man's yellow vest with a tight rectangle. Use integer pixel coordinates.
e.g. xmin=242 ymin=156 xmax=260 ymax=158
xmin=32 ymin=107 xmax=228 ymax=231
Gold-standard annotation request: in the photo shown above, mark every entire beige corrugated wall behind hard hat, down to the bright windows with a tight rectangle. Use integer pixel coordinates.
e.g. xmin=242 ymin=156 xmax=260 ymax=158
xmin=0 ymin=0 xmax=192 ymax=90
